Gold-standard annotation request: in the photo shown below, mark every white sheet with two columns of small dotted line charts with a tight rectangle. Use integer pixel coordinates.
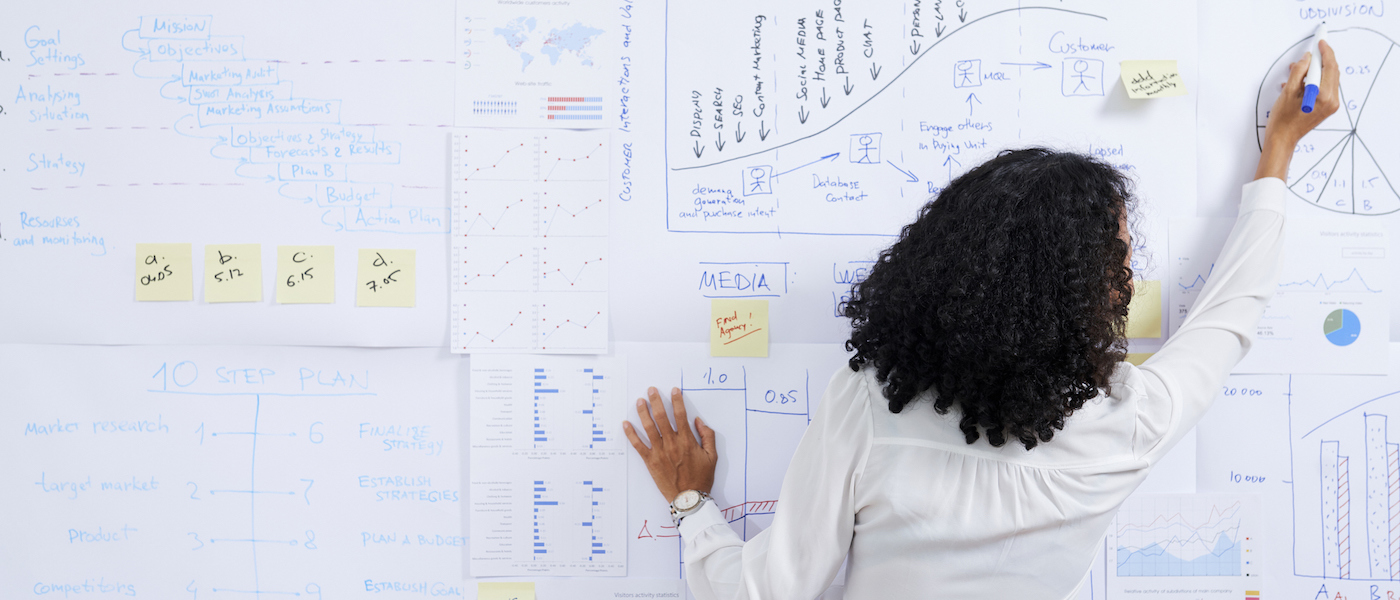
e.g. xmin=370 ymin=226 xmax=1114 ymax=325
xmin=451 ymin=129 xmax=608 ymax=354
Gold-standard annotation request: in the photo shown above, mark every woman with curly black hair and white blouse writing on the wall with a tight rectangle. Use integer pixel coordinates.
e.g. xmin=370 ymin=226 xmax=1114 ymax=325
xmin=624 ymin=42 xmax=1338 ymax=600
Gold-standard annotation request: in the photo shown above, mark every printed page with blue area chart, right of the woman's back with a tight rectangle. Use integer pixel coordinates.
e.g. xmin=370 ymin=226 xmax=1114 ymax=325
xmin=1107 ymin=494 xmax=1264 ymax=600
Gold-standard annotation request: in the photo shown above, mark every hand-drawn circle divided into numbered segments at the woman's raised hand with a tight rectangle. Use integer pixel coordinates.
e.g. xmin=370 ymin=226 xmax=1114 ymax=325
xmin=1254 ymin=27 xmax=1400 ymax=215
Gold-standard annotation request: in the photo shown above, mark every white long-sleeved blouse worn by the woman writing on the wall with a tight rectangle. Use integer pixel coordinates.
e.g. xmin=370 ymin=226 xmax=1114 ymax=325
xmin=680 ymin=178 xmax=1285 ymax=600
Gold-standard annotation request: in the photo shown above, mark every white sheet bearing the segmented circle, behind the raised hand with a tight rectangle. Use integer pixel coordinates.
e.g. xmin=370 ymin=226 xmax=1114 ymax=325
xmin=1197 ymin=0 xmax=1400 ymax=338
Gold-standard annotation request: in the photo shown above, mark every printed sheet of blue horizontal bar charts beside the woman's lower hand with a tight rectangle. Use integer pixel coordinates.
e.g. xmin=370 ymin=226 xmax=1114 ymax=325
xmin=469 ymin=355 xmax=630 ymax=578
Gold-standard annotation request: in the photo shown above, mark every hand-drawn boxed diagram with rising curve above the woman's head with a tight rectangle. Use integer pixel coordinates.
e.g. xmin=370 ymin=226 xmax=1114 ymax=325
xmin=665 ymin=1 xmax=1191 ymax=235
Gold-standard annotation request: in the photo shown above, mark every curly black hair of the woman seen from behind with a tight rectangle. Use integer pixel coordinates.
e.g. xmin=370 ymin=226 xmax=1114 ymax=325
xmin=841 ymin=148 xmax=1135 ymax=449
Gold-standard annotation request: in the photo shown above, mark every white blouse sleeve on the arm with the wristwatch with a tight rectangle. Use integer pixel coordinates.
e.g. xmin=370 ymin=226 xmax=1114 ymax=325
xmin=680 ymin=368 xmax=874 ymax=600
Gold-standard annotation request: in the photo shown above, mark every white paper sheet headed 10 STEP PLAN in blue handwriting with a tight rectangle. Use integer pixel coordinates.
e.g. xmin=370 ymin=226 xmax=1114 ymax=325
xmin=0 ymin=345 xmax=466 ymax=599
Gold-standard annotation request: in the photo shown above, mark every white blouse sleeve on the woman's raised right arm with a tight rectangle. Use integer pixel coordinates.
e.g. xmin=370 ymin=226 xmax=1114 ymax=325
xmin=1130 ymin=178 xmax=1287 ymax=463
